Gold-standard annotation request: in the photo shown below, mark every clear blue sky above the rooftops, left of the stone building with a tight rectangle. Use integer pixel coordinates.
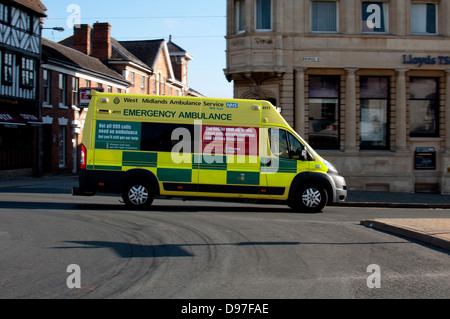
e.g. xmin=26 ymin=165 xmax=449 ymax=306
xmin=42 ymin=0 xmax=233 ymax=98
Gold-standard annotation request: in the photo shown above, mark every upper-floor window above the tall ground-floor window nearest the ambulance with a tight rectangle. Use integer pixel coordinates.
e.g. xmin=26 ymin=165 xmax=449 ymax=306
xmin=311 ymin=1 xmax=337 ymax=32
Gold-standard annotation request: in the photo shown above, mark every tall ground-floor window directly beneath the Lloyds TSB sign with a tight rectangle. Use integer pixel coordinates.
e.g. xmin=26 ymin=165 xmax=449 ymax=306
xmin=409 ymin=77 xmax=439 ymax=137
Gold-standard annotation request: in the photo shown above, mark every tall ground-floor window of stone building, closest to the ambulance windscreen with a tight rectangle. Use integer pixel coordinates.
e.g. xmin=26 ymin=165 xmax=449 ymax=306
xmin=309 ymin=76 xmax=340 ymax=149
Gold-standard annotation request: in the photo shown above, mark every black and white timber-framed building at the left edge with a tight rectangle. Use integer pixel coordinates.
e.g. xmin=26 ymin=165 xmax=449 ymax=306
xmin=0 ymin=0 xmax=46 ymax=175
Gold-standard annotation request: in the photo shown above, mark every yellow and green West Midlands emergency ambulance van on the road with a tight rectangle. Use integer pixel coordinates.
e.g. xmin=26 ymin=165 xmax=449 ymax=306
xmin=73 ymin=91 xmax=347 ymax=213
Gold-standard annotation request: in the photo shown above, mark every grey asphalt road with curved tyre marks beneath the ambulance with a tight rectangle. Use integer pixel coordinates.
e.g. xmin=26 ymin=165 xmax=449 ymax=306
xmin=0 ymin=188 xmax=450 ymax=299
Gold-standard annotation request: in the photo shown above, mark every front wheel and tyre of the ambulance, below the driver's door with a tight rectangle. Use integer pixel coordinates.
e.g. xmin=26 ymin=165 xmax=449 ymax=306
xmin=289 ymin=185 xmax=328 ymax=213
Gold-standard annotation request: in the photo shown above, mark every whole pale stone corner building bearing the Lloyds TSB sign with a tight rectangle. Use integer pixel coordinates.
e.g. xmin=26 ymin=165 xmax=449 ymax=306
xmin=224 ymin=0 xmax=450 ymax=193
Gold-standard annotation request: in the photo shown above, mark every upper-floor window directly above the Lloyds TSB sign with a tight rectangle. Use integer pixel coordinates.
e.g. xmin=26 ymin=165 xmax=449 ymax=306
xmin=411 ymin=3 xmax=437 ymax=34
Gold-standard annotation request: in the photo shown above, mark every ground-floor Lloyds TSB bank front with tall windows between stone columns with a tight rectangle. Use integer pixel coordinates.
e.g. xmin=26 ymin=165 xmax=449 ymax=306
xmin=293 ymin=52 xmax=450 ymax=193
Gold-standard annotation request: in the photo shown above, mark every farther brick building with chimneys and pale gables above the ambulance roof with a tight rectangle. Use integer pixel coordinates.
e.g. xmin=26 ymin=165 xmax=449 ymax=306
xmin=60 ymin=22 xmax=201 ymax=96
